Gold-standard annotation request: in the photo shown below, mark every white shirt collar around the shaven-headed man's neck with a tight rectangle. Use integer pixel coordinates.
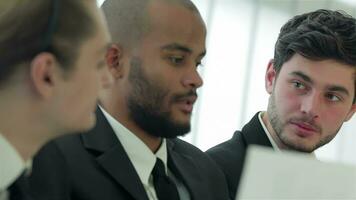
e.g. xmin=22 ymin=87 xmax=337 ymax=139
xmin=100 ymin=107 xmax=167 ymax=184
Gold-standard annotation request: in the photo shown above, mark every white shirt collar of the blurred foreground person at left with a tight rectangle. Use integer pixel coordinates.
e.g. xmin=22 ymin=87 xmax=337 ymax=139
xmin=0 ymin=133 xmax=25 ymax=200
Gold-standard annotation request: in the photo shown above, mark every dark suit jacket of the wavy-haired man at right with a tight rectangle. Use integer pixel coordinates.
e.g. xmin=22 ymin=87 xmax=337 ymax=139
xmin=206 ymin=113 xmax=272 ymax=199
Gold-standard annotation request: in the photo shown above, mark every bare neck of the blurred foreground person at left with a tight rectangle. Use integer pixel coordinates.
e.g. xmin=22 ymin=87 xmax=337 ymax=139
xmin=0 ymin=93 xmax=49 ymax=161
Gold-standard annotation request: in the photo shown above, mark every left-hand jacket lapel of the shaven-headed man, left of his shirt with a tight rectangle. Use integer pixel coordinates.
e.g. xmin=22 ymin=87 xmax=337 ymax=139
xmin=81 ymin=108 xmax=148 ymax=200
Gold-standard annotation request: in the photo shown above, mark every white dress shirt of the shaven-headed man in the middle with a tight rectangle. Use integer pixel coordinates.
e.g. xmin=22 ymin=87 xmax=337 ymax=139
xmin=100 ymin=107 xmax=190 ymax=200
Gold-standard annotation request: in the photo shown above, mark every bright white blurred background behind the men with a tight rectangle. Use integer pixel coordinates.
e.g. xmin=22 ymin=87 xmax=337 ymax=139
xmin=98 ymin=0 xmax=356 ymax=164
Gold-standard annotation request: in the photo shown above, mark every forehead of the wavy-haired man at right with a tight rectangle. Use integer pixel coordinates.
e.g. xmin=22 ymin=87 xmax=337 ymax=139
xmin=280 ymin=54 xmax=355 ymax=89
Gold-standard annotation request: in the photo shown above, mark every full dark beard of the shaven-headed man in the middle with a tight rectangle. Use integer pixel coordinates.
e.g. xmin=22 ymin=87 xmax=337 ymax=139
xmin=127 ymin=57 xmax=197 ymax=138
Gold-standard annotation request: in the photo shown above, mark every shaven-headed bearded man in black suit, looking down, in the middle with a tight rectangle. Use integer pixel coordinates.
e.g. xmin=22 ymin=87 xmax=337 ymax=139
xmin=27 ymin=0 xmax=228 ymax=200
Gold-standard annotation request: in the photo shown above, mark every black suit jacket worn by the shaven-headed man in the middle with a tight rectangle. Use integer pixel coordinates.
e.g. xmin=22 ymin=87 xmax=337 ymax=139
xmin=30 ymin=110 xmax=228 ymax=200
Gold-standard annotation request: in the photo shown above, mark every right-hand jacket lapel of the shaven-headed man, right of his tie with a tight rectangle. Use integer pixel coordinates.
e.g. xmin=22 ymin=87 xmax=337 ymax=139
xmin=167 ymin=139 xmax=206 ymax=199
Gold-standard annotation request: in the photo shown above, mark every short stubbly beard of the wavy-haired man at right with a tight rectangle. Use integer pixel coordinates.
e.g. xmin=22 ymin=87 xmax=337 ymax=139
xmin=267 ymin=92 xmax=341 ymax=153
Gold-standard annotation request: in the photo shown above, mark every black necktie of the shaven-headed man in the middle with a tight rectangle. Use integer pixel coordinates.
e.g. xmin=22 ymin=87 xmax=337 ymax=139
xmin=152 ymin=158 xmax=179 ymax=200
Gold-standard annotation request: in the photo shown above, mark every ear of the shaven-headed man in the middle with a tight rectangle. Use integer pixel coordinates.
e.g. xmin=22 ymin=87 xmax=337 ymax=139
xmin=106 ymin=44 xmax=124 ymax=79
